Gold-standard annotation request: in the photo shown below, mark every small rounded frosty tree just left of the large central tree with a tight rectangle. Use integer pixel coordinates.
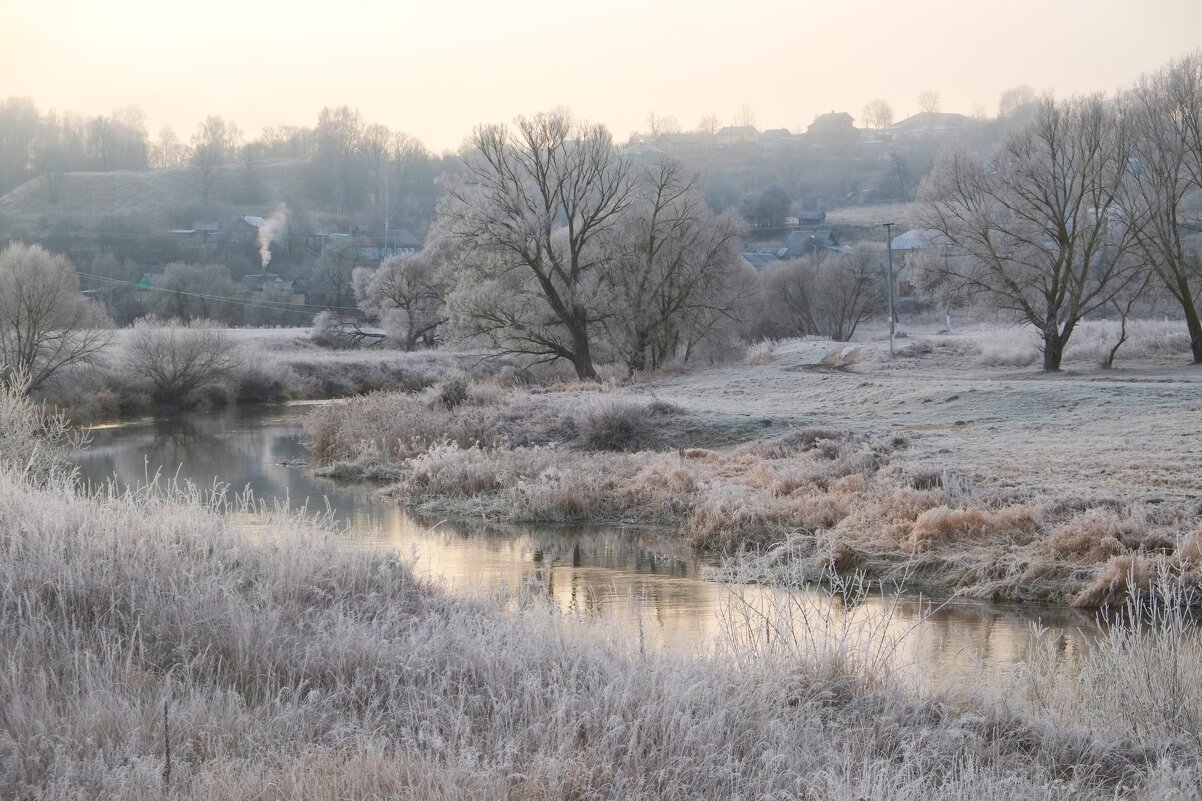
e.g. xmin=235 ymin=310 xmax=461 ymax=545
xmin=355 ymin=254 xmax=447 ymax=350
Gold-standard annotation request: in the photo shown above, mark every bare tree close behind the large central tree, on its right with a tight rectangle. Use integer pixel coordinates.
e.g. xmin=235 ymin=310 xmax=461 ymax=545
xmin=603 ymin=159 xmax=754 ymax=372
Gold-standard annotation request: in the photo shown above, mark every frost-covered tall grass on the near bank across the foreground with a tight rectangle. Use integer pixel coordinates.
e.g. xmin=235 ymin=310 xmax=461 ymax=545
xmin=0 ymin=384 xmax=1202 ymax=801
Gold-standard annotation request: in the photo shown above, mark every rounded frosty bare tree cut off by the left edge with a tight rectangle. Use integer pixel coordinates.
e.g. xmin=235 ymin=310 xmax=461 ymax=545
xmin=0 ymin=242 xmax=112 ymax=391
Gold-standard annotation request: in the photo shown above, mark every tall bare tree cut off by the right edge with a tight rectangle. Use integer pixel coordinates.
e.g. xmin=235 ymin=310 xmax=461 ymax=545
xmin=1124 ymin=51 xmax=1202 ymax=363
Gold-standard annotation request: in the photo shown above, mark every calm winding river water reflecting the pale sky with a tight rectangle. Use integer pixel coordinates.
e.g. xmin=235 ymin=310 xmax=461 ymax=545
xmin=77 ymin=405 xmax=1095 ymax=677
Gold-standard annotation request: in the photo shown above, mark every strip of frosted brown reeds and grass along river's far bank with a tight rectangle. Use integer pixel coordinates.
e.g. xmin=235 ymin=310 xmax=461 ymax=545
xmin=307 ymin=384 xmax=1192 ymax=605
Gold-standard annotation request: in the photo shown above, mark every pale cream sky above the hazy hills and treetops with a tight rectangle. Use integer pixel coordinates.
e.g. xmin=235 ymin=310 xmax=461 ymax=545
xmin=0 ymin=0 xmax=1202 ymax=150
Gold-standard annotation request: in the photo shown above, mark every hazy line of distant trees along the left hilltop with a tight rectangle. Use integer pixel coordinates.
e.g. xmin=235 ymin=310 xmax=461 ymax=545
xmin=0 ymin=97 xmax=448 ymax=229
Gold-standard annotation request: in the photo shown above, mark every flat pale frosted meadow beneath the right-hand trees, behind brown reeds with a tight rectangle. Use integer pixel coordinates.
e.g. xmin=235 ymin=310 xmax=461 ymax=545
xmin=633 ymin=328 xmax=1202 ymax=504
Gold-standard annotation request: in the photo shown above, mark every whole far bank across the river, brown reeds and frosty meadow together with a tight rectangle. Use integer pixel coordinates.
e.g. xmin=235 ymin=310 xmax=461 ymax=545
xmin=308 ymin=332 xmax=1202 ymax=606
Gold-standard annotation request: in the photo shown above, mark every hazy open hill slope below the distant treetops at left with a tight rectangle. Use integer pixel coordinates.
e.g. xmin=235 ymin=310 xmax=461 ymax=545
xmin=0 ymin=160 xmax=337 ymax=231
